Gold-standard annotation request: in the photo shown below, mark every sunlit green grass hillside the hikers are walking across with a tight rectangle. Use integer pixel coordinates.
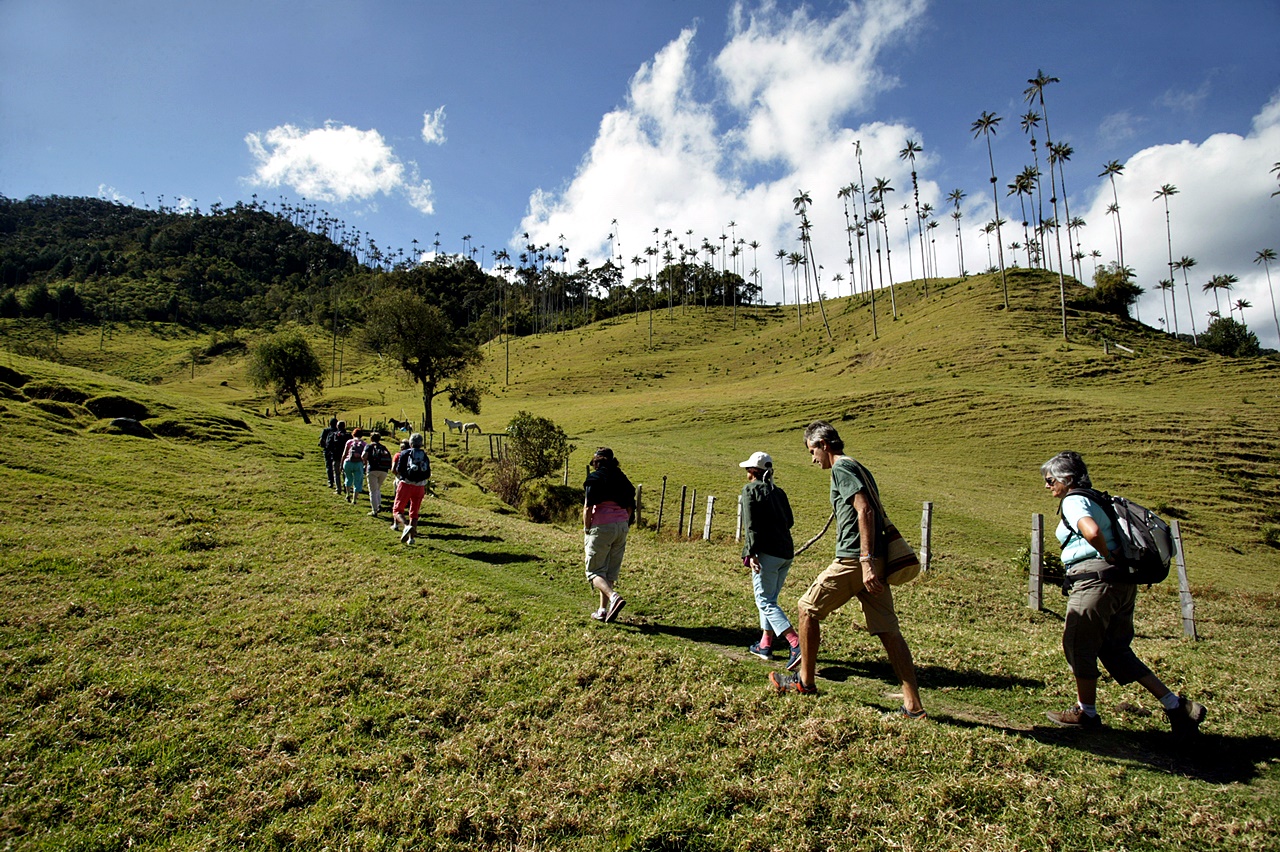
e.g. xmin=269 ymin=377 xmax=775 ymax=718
xmin=0 ymin=272 xmax=1280 ymax=849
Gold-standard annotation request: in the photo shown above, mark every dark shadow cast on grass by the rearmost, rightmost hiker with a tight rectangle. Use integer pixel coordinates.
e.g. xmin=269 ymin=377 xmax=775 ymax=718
xmin=929 ymin=713 xmax=1280 ymax=784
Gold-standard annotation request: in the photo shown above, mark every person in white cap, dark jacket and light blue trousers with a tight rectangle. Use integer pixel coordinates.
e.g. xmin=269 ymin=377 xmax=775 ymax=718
xmin=739 ymin=452 xmax=800 ymax=669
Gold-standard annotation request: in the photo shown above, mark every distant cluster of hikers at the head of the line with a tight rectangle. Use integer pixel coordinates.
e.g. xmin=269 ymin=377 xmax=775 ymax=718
xmin=320 ymin=417 xmax=431 ymax=544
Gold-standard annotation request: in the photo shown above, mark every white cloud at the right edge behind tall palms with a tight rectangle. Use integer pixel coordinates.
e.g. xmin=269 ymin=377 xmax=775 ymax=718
xmin=1073 ymin=92 xmax=1280 ymax=348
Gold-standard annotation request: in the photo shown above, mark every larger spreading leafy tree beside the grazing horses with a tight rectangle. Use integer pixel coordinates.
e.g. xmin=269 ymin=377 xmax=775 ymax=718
xmin=361 ymin=289 xmax=484 ymax=429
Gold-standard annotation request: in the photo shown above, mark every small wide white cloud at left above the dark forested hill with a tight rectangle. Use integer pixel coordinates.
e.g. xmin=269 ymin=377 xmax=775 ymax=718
xmin=244 ymin=120 xmax=443 ymax=214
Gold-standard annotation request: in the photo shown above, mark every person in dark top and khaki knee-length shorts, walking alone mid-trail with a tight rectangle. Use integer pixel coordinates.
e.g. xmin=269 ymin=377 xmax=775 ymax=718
xmin=582 ymin=446 xmax=636 ymax=623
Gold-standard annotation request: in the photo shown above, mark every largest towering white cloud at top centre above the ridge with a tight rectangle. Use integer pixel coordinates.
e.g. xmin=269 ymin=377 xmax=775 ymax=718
xmin=520 ymin=0 xmax=941 ymax=301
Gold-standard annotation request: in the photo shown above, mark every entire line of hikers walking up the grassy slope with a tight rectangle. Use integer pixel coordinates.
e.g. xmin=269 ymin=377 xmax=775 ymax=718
xmin=314 ymin=411 xmax=1206 ymax=739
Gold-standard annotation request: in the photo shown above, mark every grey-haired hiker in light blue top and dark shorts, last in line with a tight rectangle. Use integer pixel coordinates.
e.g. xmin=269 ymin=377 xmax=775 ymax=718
xmin=1041 ymin=450 xmax=1206 ymax=739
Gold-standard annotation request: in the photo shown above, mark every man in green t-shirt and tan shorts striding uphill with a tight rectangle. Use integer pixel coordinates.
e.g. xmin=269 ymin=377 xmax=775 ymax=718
xmin=769 ymin=420 xmax=927 ymax=719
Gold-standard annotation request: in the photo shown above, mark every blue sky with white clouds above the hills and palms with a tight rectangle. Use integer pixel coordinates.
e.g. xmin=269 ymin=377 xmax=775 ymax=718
xmin=0 ymin=0 xmax=1280 ymax=345
